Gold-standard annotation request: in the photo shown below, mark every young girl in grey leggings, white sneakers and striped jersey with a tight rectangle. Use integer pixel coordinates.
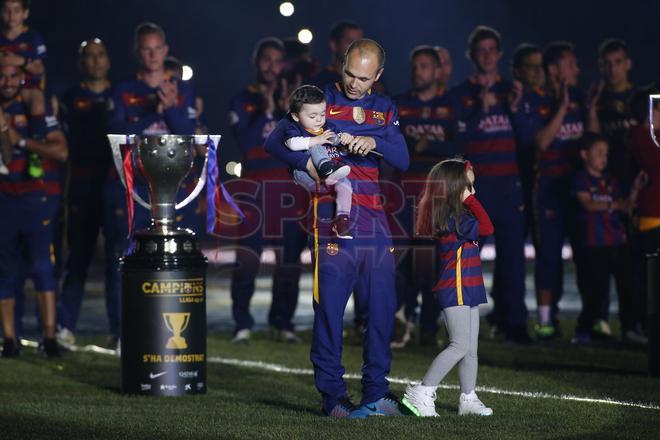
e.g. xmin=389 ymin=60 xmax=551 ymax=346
xmin=402 ymin=159 xmax=493 ymax=417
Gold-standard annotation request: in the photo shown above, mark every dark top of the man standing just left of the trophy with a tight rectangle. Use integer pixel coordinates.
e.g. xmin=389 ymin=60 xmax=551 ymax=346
xmin=61 ymin=82 xmax=112 ymax=182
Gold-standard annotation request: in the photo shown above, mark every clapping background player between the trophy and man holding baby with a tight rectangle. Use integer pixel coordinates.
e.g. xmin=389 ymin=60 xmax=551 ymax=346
xmin=229 ymin=37 xmax=309 ymax=343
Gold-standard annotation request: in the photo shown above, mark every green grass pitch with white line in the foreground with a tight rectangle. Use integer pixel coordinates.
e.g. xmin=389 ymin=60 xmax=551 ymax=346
xmin=0 ymin=324 xmax=660 ymax=440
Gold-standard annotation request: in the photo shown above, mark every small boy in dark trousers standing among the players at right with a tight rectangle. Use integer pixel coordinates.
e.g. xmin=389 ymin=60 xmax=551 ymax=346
xmin=571 ymin=133 xmax=643 ymax=344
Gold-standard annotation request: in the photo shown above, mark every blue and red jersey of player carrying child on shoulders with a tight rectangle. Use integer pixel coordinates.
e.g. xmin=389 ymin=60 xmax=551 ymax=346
xmin=0 ymin=95 xmax=46 ymax=196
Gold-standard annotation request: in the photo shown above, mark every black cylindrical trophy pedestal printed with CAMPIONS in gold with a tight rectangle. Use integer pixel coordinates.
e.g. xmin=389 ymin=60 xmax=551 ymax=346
xmin=120 ymin=227 xmax=208 ymax=396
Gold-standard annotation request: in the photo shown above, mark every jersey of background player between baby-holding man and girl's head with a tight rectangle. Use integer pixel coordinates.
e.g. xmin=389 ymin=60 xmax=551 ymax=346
xmin=394 ymin=87 xmax=462 ymax=179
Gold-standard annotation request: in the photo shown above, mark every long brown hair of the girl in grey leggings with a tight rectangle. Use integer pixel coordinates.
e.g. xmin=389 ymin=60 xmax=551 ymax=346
xmin=416 ymin=159 xmax=471 ymax=236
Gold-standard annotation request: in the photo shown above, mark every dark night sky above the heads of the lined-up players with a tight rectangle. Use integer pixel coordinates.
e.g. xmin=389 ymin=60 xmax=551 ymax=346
xmin=28 ymin=0 xmax=660 ymax=169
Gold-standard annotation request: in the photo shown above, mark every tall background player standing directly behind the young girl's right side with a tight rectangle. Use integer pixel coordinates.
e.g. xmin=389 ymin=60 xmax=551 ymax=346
xmin=451 ymin=26 xmax=529 ymax=343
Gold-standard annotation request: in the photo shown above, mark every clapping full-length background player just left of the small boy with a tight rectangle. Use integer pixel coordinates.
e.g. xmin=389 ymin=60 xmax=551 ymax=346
xmin=516 ymin=42 xmax=599 ymax=339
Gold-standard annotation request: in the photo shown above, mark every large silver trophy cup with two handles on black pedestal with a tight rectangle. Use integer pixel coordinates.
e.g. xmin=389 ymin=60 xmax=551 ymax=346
xmin=108 ymin=134 xmax=220 ymax=232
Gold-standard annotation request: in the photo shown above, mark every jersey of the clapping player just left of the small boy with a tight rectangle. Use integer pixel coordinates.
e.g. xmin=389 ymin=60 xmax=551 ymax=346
xmin=516 ymin=87 xmax=587 ymax=178
